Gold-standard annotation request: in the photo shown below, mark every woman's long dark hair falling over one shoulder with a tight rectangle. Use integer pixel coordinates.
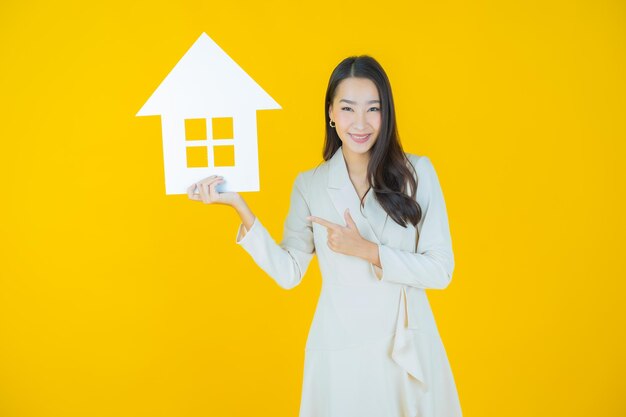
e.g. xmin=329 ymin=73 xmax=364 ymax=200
xmin=322 ymin=55 xmax=422 ymax=227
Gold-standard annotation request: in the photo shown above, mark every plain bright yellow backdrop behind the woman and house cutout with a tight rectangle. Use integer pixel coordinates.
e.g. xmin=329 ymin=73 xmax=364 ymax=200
xmin=0 ymin=0 xmax=626 ymax=417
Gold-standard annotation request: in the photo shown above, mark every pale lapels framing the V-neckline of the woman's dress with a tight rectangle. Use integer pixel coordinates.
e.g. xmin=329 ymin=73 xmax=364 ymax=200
xmin=328 ymin=147 xmax=388 ymax=244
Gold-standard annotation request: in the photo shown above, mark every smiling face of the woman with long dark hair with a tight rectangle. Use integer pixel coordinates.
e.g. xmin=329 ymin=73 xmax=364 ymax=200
xmin=328 ymin=77 xmax=381 ymax=158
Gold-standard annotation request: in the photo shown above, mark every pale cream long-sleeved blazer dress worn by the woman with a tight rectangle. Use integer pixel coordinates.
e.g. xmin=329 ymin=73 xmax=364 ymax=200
xmin=235 ymin=147 xmax=462 ymax=417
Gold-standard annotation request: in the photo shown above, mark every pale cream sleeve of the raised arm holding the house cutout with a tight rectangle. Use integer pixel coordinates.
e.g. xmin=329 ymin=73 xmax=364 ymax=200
xmin=235 ymin=173 xmax=315 ymax=289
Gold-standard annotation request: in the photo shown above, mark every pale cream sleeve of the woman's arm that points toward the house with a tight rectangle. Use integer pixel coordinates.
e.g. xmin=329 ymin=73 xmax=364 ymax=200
xmin=370 ymin=156 xmax=454 ymax=289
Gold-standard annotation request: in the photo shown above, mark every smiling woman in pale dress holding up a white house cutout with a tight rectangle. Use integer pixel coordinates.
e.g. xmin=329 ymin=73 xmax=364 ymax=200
xmin=188 ymin=56 xmax=461 ymax=417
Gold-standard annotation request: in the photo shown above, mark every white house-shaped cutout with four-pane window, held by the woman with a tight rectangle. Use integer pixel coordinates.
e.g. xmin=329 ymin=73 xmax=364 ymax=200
xmin=136 ymin=33 xmax=281 ymax=194
